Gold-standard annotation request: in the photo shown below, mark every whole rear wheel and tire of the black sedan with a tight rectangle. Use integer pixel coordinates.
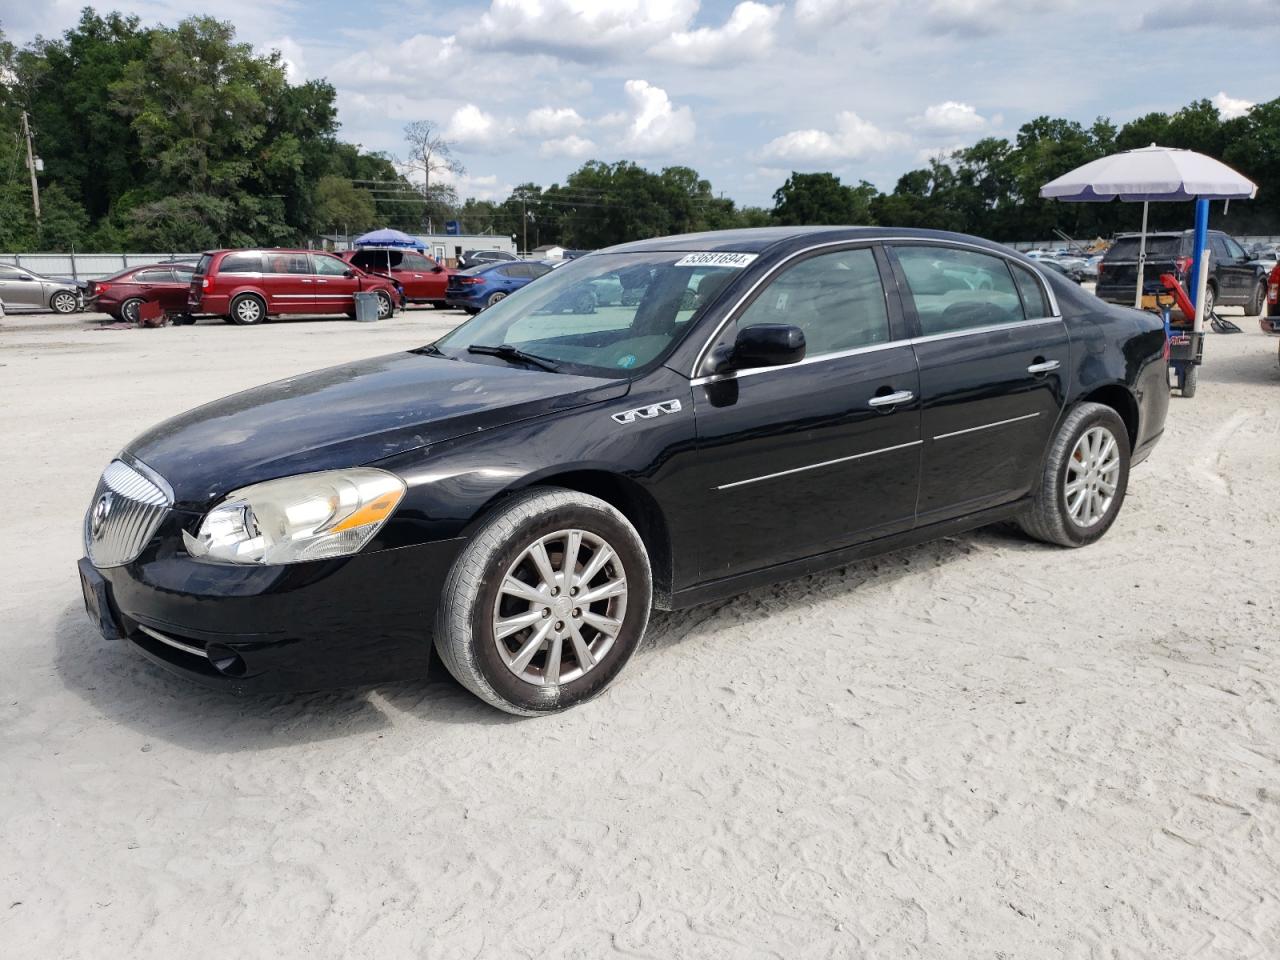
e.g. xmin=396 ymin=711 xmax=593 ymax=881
xmin=1016 ymin=403 xmax=1130 ymax=547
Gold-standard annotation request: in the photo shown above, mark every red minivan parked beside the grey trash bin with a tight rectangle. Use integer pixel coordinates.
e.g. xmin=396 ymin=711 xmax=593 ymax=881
xmin=187 ymin=250 xmax=399 ymax=326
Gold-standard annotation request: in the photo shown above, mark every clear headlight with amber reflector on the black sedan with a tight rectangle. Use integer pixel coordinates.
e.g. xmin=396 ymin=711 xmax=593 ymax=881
xmin=182 ymin=467 xmax=404 ymax=564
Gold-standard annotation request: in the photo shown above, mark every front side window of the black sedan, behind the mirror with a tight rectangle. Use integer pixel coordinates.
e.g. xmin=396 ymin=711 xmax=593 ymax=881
xmin=737 ymin=247 xmax=890 ymax=357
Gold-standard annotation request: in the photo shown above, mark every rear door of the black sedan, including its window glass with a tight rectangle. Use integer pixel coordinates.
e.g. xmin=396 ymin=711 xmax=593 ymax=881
xmin=892 ymin=243 xmax=1069 ymax=525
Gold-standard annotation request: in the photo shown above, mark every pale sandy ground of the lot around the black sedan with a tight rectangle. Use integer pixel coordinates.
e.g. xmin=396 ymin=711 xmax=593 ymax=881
xmin=0 ymin=302 xmax=1280 ymax=960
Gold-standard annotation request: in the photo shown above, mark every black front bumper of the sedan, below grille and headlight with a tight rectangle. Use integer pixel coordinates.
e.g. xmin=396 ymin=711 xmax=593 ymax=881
xmin=79 ymin=539 xmax=463 ymax=692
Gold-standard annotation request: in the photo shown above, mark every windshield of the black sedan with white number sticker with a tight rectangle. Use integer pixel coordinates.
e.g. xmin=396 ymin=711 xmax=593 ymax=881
xmin=435 ymin=252 xmax=754 ymax=376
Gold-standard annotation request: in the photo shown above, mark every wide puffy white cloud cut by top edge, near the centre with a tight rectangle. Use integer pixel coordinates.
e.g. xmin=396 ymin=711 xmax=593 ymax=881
xmin=458 ymin=0 xmax=698 ymax=61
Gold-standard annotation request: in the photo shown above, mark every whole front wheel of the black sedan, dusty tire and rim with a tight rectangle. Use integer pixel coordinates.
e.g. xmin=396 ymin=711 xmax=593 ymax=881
xmin=435 ymin=486 xmax=653 ymax=717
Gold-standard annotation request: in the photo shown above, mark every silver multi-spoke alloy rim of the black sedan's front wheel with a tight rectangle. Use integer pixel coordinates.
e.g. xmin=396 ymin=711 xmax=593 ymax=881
xmin=493 ymin=530 xmax=628 ymax=686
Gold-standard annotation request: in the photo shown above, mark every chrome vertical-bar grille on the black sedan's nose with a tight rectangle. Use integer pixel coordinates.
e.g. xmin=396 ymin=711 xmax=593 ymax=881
xmin=84 ymin=460 xmax=173 ymax=567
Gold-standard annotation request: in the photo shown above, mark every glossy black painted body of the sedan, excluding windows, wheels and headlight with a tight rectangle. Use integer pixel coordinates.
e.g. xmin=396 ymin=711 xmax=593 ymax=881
xmin=74 ymin=228 xmax=1169 ymax=689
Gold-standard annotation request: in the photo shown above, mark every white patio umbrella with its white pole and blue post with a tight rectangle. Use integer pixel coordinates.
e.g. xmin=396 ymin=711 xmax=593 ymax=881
xmin=1041 ymin=143 xmax=1258 ymax=312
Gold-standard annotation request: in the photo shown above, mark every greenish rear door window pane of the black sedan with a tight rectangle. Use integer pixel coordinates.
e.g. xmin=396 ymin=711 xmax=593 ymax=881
xmin=895 ymin=244 xmax=1025 ymax=337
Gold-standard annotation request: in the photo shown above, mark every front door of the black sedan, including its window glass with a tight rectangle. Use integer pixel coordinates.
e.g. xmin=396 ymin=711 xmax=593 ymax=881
xmin=692 ymin=246 xmax=920 ymax=581
